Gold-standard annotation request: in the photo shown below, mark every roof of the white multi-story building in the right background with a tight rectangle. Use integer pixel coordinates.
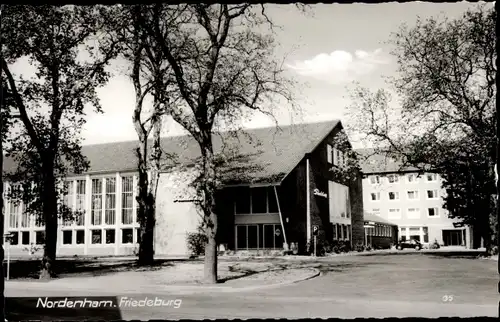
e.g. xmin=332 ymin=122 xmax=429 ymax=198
xmin=356 ymin=149 xmax=418 ymax=174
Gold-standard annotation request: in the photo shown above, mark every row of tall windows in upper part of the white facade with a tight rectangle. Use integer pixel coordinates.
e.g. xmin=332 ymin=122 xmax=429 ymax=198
xmin=8 ymin=176 xmax=139 ymax=229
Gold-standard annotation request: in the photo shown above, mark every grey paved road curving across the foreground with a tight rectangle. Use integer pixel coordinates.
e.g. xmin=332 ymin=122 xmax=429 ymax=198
xmin=2 ymin=256 xmax=500 ymax=320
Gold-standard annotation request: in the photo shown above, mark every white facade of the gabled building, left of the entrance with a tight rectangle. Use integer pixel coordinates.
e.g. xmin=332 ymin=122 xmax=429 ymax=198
xmin=4 ymin=172 xmax=200 ymax=256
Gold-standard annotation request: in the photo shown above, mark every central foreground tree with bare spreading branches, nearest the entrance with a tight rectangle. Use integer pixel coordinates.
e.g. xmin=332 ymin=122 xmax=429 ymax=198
xmin=137 ymin=4 xmax=295 ymax=283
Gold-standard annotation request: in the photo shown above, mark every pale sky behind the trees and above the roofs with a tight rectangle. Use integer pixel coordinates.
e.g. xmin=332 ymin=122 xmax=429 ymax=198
xmin=7 ymin=2 xmax=490 ymax=147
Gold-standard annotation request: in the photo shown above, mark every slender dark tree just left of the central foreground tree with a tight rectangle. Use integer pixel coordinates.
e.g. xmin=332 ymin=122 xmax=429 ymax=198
xmin=110 ymin=5 xmax=182 ymax=265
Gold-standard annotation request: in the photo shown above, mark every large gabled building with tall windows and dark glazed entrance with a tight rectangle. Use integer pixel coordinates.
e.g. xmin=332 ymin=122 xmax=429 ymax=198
xmin=4 ymin=120 xmax=364 ymax=256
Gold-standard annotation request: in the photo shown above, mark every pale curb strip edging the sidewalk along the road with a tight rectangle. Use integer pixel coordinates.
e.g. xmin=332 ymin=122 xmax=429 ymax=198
xmin=5 ymin=268 xmax=321 ymax=294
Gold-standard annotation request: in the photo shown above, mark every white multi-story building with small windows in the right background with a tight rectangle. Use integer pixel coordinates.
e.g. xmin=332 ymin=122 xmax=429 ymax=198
xmin=358 ymin=149 xmax=472 ymax=248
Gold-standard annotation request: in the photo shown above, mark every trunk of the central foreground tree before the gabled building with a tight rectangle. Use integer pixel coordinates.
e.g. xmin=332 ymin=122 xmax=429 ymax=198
xmin=201 ymin=141 xmax=218 ymax=284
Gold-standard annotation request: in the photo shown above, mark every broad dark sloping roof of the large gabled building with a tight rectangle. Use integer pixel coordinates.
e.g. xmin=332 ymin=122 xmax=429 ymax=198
xmin=4 ymin=120 xmax=340 ymax=184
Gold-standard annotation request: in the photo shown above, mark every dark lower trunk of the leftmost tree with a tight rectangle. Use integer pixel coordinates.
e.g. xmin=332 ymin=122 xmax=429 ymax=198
xmin=40 ymin=169 xmax=57 ymax=279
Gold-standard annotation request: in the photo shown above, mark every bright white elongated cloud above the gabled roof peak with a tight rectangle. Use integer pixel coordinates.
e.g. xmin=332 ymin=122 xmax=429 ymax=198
xmin=287 ymin=48 xmax=389 ymax=84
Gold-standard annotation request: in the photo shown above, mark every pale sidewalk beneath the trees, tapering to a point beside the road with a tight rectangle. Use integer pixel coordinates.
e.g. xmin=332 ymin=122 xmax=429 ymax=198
xmin=5 ymin=265 xmax=320 ymax=294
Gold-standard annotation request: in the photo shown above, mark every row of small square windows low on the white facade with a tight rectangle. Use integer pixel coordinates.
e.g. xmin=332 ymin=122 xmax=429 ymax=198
xmin=5 ymin=228 xmax=140 ymax=245
